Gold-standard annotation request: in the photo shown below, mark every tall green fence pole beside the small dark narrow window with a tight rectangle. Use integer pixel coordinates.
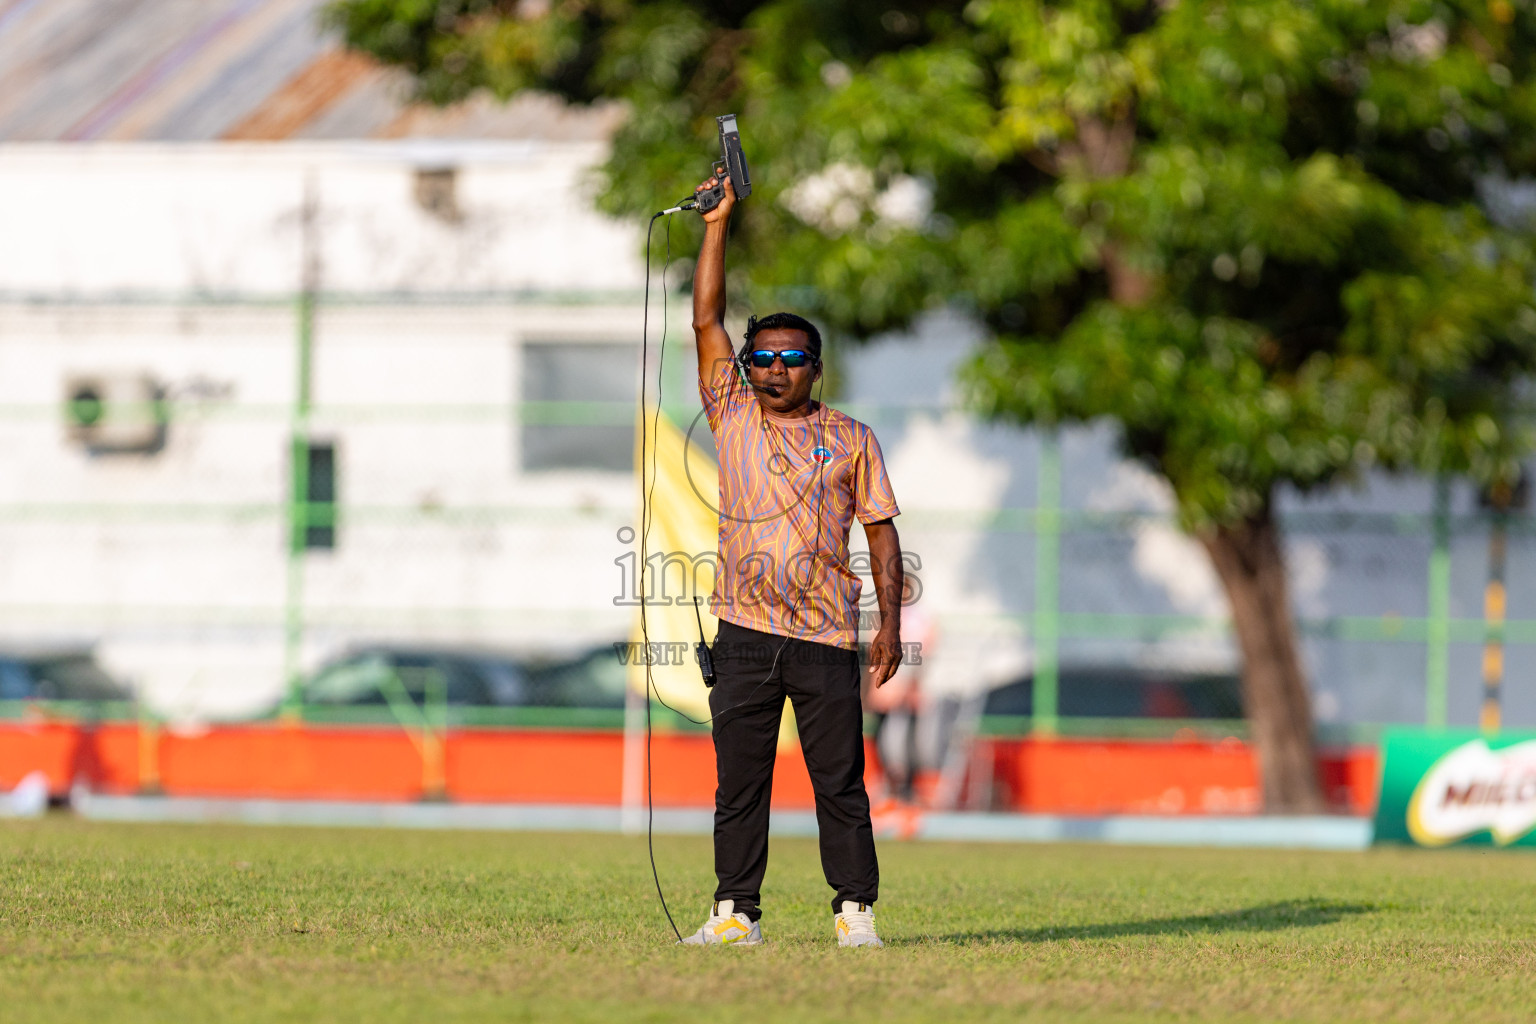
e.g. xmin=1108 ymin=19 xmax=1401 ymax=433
xmin=281 ymin=178 xmax=319 ymax=722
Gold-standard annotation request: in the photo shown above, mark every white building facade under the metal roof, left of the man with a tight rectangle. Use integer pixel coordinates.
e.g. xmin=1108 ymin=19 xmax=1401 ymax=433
xmin=0 ymin=143 xmax=642 ymax=714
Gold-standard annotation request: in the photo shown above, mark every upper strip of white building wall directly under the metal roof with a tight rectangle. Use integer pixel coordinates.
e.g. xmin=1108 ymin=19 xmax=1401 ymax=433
xmin=0 ymin=140 xmax=644 ymax=298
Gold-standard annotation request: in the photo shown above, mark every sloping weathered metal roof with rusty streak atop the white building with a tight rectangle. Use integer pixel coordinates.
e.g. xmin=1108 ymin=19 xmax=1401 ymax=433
xmin=0 ymin=0 xmax=621 ymax=141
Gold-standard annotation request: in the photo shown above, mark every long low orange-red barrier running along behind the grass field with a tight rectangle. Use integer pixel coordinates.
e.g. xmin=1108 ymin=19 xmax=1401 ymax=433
xmin=0 ymin=720 xmax=1376 ymax=815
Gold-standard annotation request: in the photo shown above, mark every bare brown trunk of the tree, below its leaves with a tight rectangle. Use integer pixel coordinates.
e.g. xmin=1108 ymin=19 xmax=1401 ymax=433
xmin=1200 ymin=502 xmax=1324 ymax=814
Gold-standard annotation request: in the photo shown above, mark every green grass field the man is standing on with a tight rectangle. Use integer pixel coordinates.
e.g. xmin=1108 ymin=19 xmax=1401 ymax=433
xmin=0 ymin=817 xmax=1536 ymax=1024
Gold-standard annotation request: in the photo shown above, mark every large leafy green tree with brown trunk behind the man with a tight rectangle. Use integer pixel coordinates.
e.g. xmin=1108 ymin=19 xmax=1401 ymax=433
xmin=330 ymin=0 xmax=1536 ymax=811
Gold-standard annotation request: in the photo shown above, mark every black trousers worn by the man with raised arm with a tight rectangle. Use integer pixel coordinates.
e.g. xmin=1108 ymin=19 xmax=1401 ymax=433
xmin=710 ymin=622 xmax=880 ymax=921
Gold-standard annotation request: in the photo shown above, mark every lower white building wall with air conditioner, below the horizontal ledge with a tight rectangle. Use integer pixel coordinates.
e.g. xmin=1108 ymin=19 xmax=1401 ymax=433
xmin=0 ymin=296 xmax=637 ymax=714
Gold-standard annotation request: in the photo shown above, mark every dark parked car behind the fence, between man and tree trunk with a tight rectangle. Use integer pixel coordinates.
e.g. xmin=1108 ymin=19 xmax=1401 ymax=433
xmin=982 ymin=666 xmax=1243 ymax=720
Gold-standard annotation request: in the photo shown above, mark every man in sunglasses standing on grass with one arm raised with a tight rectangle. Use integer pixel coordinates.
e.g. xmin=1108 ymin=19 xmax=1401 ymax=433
xmin=684 ymin=170 xmax=905 ymax=946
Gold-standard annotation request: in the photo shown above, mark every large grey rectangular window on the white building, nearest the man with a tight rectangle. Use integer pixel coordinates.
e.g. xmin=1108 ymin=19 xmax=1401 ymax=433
xmin=521 ymin=342 xmax=636 ymax=473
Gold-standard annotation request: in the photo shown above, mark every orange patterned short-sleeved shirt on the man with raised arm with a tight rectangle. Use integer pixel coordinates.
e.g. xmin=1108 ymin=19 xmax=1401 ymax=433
xmin=699 ymin=362 xmax=902 ymax=648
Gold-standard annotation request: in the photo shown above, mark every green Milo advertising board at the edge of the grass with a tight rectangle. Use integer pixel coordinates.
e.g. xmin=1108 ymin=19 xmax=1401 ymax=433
xmin=1376 ymin=729 xmax=1536 ymax=846
